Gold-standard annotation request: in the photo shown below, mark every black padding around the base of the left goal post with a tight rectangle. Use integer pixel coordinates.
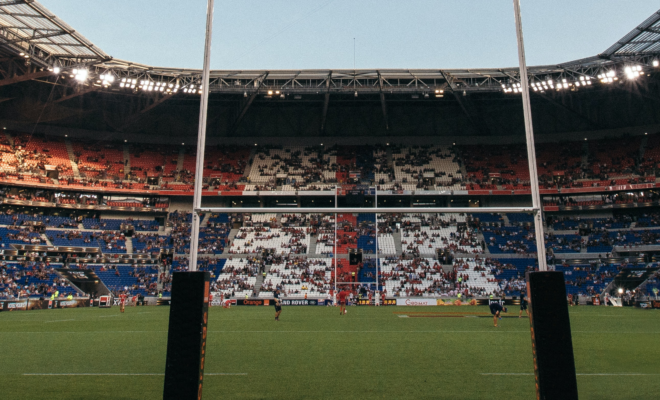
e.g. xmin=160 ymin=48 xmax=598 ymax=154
xmin=163 ymin=272 xmax=210 ymax=400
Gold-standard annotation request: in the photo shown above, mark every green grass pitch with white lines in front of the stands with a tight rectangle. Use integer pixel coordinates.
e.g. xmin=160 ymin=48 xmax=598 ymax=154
xmin=0 ymin=306 xmax=660 ymax=400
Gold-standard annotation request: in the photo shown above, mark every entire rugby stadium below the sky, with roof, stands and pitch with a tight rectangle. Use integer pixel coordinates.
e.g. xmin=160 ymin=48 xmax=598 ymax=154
xmin=0 ymin=0 xmax=660 ymax=400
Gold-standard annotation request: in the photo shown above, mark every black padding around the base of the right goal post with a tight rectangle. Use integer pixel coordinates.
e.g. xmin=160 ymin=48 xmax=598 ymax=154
xmin=527 ymin=271 xmax=578 ymax=400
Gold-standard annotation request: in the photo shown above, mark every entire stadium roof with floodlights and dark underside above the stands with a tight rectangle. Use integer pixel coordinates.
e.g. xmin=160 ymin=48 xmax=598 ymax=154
xmin=0 ymin=0 xmax=660 ymax=140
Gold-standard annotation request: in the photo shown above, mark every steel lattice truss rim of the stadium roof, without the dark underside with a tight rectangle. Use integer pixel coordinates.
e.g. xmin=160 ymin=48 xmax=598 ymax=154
xmin=0 ymin=0 xmax=660 ymax=94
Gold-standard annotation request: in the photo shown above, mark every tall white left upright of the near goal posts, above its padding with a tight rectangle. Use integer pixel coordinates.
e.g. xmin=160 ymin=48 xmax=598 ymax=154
xmin=188 ymin=0 xmax=215 ymax=271
